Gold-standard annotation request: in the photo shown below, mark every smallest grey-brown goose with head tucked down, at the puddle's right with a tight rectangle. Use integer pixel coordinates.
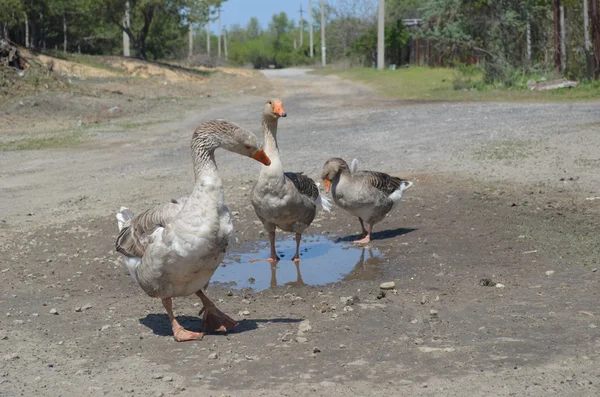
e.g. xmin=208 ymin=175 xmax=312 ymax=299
xmin=321 ymin=157 xmax=413 ymax=244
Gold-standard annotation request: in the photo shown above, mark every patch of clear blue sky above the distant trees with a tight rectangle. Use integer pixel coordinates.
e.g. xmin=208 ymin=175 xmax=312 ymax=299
xmin=210 ymin=0 xmax=304 ymax=31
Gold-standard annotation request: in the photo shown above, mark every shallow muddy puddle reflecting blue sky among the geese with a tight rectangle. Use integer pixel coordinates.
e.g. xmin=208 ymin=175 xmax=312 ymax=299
xmin=211 ymin=235 xmax=383 ymax=291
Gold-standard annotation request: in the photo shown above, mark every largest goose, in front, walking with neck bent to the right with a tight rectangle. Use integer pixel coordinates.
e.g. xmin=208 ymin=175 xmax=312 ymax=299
xmin=115 ymin=120 xmax=270 ymax=342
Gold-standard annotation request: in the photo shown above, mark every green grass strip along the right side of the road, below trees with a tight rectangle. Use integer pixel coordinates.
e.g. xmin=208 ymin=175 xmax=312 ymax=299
xmin=312 ymin=67 xmax=600 ymax=102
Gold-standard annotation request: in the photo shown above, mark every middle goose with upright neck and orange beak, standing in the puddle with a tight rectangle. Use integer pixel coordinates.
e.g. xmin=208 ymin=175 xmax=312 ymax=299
xmin=251 ymin=99 xmax=330 ymax=262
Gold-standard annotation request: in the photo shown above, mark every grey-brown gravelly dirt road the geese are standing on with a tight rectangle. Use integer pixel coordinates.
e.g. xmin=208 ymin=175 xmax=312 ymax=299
xmin=0 ymin=70 xmax=600 ymax=396
